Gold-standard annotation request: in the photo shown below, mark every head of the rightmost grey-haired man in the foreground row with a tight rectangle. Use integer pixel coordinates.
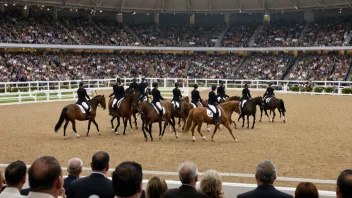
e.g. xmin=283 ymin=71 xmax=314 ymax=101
xmin=256 ymin=160 xmax=276 ymax=184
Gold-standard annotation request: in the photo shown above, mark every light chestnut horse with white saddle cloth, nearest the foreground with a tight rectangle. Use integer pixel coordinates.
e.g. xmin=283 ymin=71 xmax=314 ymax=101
xmin=185 ymin=107 xmax=238 ymax=142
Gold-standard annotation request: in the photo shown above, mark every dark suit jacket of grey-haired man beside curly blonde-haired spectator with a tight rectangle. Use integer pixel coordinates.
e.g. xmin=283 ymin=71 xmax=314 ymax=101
xmin=165 ymin=185 xmax=210 ymax=198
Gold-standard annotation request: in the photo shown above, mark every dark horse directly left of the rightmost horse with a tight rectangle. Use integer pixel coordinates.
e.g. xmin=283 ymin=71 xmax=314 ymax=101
xmin=238 ymin=97 xmax=262 ymax=129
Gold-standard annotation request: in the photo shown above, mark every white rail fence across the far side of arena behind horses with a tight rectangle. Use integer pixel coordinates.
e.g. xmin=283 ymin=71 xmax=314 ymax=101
xmin=0 ymin=78 xmax=352 ymax=105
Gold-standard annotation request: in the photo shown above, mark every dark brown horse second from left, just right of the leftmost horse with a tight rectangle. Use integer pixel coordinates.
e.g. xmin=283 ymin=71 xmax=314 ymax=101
xmin=109 ymin=92 xmax=138 ymax=135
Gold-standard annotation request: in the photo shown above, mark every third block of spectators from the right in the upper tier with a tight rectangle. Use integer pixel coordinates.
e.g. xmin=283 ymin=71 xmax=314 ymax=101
xmin=221 ymin=23 xmax=257 ymax=47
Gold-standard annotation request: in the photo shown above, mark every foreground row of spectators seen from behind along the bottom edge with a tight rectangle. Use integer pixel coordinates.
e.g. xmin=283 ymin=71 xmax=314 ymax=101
xmin=0 ymin=151 xmax=352 ymax=198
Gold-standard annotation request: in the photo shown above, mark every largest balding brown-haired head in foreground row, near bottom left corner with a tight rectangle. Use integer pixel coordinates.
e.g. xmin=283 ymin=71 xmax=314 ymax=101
xmin=28 ymin=156 xmax=62 ymax=192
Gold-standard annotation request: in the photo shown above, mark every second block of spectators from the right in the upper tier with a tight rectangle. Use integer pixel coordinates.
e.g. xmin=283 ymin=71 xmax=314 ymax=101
xmin=255 ymin=20 xmax=304 ymax=47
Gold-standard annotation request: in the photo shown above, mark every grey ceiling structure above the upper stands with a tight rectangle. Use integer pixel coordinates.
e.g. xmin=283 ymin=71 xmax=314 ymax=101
xmin=3 ymin=0 xmax=352 ymax=13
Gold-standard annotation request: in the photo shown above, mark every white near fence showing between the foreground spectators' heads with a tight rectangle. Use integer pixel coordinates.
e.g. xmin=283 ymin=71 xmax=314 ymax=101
xmin=0 ymin=164 xmax=336 ymax=198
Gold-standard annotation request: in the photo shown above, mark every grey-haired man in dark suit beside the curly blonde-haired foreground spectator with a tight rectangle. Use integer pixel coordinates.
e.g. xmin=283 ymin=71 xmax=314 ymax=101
xmin=165 ymin=162 xmax=208 ymax=198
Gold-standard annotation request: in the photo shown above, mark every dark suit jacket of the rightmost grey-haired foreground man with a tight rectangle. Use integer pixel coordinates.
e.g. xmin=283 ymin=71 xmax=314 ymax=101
xmin=237 ymin=185 xmax=293 ymax=198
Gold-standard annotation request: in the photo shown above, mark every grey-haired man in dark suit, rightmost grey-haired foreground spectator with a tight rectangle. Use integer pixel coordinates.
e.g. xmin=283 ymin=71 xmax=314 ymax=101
xmin=237 ymin=160 xmax=293 ymax=198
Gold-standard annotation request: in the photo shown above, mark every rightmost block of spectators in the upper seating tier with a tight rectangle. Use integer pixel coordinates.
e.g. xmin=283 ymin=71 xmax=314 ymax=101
xmin=299 ymin=16 xmax=352 ymax=47
